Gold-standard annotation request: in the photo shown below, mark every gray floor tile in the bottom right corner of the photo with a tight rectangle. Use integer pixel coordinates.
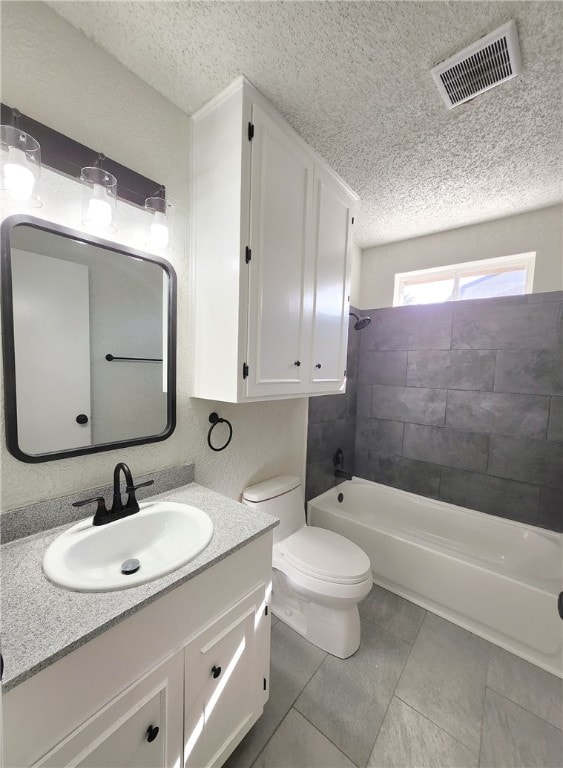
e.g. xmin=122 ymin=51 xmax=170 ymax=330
xmin=480 ymin=688 xmax=563 ymax=768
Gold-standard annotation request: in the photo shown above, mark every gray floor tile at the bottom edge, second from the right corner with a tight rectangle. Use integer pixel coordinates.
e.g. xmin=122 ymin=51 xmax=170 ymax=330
xmin=368 ymin=698 xmax=479 ymax=768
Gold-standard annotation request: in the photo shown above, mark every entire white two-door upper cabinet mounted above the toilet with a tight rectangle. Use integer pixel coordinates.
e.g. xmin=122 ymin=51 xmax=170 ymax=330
xmin=191 ymin=78 xmax=357 ymax=402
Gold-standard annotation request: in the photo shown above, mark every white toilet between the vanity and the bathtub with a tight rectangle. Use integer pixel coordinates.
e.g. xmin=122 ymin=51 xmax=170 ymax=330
xmin=242 ymin=475 xmax=373 ymax=659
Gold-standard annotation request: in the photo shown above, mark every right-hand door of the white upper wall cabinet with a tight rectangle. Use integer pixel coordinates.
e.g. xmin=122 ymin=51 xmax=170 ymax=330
xmin=310 ymin=166 xmax=354 ymax=391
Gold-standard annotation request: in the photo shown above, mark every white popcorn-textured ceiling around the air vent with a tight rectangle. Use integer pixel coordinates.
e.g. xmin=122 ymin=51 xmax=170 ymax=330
xmin=49 ymin=0 xmax=563 ymax=248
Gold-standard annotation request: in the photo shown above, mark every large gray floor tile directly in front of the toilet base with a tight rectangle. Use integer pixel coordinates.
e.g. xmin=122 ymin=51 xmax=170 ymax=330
xmin=295 ymin=621 xmax=411 ymax=766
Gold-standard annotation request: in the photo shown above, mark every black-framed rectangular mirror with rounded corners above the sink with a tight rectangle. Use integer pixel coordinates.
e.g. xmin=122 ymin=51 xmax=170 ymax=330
xmin=1 ymin=215 xmax=176 ymax=462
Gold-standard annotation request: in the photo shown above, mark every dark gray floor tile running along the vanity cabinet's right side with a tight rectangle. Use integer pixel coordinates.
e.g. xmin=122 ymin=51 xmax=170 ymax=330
xmin=225 ymin=621 xmax=326 ymax=768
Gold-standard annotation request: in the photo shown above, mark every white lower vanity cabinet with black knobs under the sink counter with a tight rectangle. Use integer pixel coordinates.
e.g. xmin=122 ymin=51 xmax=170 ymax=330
xmin=3 ymin=532 xmax=272 ymax=768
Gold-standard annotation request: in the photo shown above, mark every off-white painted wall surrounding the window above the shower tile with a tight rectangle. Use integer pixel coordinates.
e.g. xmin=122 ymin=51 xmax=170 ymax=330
xmin=358 ymin=205 xmax=563 ymax=309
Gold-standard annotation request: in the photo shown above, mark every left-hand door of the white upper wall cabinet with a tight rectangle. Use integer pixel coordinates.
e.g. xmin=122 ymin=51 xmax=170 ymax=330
xmin=247 ymin=104 xmax=313 ymax=397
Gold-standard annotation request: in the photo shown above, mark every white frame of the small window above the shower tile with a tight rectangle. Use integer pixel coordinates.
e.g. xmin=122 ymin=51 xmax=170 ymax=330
xmin=393 ymin=251 xmax=536 ymax=307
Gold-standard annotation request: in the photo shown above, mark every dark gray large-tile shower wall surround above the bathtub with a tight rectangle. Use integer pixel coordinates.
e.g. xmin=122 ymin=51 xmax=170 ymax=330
xmin=307 ymin=291 xmax=563 ymax=531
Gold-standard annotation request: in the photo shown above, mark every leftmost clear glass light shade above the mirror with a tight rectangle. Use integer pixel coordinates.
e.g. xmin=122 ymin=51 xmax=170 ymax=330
xmin=0 ymin=121 xmax=41 ymax=208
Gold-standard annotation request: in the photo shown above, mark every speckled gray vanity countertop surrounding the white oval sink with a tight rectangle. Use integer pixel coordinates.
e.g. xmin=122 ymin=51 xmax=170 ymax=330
xmin=0 ymin=483 xmax=277 ymax=692
